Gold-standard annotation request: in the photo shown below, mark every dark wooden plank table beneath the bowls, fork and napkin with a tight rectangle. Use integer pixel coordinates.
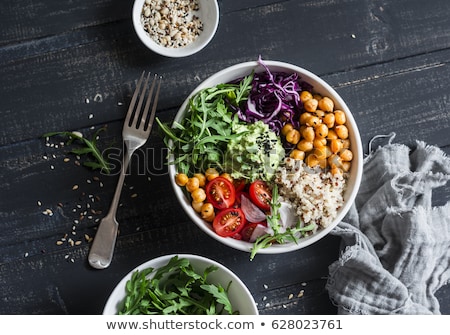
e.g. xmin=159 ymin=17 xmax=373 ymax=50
xmin=0 ymin=0 xmax=450 ymax=314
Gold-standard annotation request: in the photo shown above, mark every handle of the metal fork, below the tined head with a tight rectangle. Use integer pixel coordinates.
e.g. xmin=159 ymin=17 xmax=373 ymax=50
xmin=88 ymin=149 xmax=134 ymax=269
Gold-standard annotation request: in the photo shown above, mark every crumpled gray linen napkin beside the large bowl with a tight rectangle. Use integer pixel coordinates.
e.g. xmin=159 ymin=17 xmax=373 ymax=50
xmin=326 ymin=134 xmax=450 ymax=314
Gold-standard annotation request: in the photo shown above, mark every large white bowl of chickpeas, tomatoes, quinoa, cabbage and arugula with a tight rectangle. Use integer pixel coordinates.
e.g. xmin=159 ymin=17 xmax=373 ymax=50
xmin=157 ymin=58 xmax=363 ymax=259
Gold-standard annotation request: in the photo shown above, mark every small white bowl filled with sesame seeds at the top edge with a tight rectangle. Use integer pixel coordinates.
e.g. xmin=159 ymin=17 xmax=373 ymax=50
xmin=132 ymin=0 xmax=219 ymax=57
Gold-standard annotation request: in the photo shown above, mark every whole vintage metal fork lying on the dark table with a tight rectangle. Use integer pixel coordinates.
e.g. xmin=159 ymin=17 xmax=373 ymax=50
xmin=88 ymin=71 xmax=162 ymax=269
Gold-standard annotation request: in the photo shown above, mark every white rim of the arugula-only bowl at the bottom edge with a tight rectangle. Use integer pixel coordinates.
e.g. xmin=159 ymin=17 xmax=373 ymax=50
xmin=103 ymin=253 xmax=259 ymax=315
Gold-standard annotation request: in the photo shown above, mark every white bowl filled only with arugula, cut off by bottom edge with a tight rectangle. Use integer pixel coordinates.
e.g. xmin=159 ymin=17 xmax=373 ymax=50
xmin=103 ymin=254 xmax=258 ymax=315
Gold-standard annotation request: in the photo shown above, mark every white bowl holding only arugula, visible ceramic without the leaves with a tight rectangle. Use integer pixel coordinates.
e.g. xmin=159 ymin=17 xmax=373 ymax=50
xmin=103 ymin=254 xmax=258 ymax=315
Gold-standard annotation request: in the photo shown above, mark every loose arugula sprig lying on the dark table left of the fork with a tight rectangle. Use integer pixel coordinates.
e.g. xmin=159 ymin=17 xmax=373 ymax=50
xmin=42 ymin=127 xmax=111 ymax=174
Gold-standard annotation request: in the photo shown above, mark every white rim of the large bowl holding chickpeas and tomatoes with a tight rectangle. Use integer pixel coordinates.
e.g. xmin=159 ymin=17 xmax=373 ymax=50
xmin=169 ymin=61 xmax=363 ymax=254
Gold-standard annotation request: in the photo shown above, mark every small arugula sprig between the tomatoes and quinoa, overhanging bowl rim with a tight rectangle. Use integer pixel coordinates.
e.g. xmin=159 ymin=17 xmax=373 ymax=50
xmin=250 ymin=184 xmax=316 ymax=260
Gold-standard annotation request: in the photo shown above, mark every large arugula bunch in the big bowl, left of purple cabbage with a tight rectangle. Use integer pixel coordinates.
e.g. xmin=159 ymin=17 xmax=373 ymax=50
xmin=156 ymin=73 xmax=253 ymax=174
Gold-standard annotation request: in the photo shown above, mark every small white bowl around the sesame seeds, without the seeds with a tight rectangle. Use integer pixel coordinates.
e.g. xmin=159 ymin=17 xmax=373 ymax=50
xmin=132 ymin=0 xmax=219 ymax=58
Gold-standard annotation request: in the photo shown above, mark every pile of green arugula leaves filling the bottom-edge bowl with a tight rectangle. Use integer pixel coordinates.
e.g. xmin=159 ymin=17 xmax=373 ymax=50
xmin=119 ymin=256 xmax=239 ymax=315
